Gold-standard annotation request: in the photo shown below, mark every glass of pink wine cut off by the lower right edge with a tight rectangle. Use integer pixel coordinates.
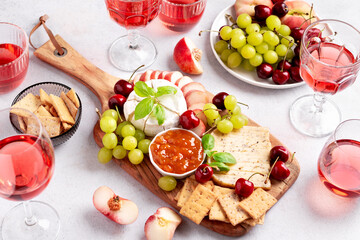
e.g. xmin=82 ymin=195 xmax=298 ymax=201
xmin=318 ymin=119 xmax=360 ymax=198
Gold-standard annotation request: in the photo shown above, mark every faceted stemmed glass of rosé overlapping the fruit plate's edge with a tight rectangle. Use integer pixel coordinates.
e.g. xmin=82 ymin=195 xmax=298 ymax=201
xmin=290 ymin=19 xmax=360 ymax=137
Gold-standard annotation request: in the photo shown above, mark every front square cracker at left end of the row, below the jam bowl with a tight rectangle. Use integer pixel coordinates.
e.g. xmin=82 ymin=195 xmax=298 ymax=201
xmin=180 ymin=184 xmax=216 ymax=224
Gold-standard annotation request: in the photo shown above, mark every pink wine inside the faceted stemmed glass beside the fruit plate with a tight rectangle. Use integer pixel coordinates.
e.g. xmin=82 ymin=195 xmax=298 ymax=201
xmin=300 ymin=42 xmax=356 ymax=94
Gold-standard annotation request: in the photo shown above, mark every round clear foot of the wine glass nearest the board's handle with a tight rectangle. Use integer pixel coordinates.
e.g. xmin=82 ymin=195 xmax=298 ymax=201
xmin=109 ymin=35 xmax=157 ymax=72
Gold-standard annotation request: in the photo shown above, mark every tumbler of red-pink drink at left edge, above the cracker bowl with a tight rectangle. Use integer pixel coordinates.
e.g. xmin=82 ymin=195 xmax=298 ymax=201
xmin=0 ymin=22 xmax=29 ymax=94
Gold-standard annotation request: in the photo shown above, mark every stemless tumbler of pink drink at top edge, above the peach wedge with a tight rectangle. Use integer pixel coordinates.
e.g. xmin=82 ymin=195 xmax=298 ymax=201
xmin=159 ymin=0 xmax=206 ymax=32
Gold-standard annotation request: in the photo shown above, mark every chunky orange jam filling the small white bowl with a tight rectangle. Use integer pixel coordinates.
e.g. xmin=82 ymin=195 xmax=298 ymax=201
xmin=150 ymin=129 xmax=204 ymax=174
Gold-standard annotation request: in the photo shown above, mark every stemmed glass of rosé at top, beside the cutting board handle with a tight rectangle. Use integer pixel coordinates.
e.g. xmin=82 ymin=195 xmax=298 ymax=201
xmin=105 ymin=0 xmax=161 ymax=72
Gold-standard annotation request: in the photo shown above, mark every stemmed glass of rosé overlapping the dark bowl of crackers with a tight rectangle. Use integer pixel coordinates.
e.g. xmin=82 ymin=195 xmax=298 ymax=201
xmin=0 ymin=108 xmax=60 ymax=240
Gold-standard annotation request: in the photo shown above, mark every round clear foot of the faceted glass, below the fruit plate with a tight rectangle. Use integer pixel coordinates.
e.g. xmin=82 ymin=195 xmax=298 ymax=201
xmin=290 ymin=95 xmax=341 ymax=137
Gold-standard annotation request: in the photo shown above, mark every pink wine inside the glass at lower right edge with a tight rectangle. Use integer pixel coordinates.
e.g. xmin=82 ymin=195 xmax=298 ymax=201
xmin=318 ymin=139 xmax=360 ymax=197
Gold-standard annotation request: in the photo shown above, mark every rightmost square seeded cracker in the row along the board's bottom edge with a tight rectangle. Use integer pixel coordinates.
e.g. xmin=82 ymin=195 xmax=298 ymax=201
xmin=239 ymin=188 xmax=277 ymax=219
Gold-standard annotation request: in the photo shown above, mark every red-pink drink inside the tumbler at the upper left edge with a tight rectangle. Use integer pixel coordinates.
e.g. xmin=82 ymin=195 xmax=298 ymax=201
xmin=0 ymin=43 xmax=29 ymax=93
